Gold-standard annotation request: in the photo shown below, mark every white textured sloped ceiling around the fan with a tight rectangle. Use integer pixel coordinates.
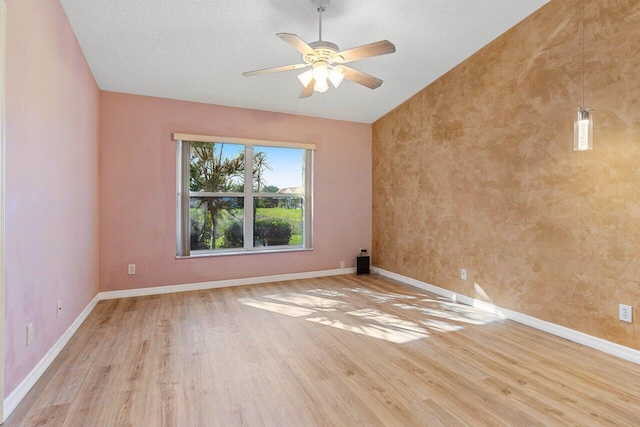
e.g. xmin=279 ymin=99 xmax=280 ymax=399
xmin=61 ymin=0 xmax=549 ymax=123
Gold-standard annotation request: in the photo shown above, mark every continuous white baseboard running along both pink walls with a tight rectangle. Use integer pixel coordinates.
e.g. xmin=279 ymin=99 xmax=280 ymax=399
xmin=3 ymin=268 xmax=355 ymax=422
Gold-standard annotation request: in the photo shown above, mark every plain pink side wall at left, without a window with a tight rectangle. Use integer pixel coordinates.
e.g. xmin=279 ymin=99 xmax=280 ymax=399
xmin=4 ymin=0 xmax=100 ymax=394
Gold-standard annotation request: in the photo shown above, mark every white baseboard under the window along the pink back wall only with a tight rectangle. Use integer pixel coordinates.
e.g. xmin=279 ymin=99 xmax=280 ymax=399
xmin=98 ymin=268 xmax=356 ymax=301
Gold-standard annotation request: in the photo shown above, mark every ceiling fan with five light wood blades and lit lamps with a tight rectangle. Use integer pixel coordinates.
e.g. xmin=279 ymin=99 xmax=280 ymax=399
xmin=242 ymin=0 xmax=396 ymax=98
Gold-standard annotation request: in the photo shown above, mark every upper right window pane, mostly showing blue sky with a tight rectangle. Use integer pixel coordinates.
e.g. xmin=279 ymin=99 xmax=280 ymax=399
xmin=253 ymin=146 xmax=304 ymax=194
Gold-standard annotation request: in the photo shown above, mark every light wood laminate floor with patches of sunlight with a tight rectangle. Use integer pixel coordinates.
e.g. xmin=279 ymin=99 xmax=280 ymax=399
xmin=6 ymin=275 xmax=640 ymax=427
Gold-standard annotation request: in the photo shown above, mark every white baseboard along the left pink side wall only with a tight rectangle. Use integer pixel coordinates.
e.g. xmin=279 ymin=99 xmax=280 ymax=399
xmin=3 ymin=295 xmax=100 ymax=422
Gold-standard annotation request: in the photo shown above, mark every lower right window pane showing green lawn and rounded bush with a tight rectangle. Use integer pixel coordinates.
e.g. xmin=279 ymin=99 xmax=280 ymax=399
xmin=253 ymin=196 xmax=303 ymax=247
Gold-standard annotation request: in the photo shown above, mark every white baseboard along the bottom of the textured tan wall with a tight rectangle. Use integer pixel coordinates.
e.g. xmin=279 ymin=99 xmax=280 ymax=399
xmin=371 ymin=267 xmax=640 ymax=365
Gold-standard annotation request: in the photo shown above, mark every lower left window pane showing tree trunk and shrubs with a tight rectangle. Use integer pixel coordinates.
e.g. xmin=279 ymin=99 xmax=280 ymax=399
xmin=189 ymin=197 xmax=244 ymax=251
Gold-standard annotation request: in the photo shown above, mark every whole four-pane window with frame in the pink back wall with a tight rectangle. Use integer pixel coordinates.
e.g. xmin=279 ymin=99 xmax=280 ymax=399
xmin=174 ymin=134 xmax=315 ymax=257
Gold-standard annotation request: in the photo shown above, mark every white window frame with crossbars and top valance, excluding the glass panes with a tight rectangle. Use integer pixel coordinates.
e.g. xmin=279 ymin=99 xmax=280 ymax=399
xmin=173 ymin=133 xmax=316 ymax=258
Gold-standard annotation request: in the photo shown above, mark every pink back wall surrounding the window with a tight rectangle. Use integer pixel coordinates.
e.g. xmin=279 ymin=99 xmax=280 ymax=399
xmin=100 ymin=92 xmax=371 ymax=291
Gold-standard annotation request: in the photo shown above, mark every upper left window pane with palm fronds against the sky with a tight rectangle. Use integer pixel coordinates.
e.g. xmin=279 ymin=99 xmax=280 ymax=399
xmin=189 ymin=142 xmax=244 ymax=193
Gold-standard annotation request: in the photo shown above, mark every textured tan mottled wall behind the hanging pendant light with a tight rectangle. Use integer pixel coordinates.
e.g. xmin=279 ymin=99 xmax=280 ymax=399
xmin=372 ymin=0 xmax=640 ymax=349
